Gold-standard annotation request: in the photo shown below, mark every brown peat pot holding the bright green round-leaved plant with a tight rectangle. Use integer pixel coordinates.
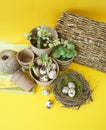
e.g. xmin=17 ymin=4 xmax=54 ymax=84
xmin=55 ymin=58 xmax=73 ymax=70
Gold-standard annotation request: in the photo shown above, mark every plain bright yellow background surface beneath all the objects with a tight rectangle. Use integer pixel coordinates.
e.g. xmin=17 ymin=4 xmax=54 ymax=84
xmin=0 ymin=0 xmax=106 ymax=130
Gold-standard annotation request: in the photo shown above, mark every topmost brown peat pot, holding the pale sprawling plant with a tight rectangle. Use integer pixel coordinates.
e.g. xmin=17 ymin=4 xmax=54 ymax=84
xmin=30 ymin=26 xmax=58 ymax=56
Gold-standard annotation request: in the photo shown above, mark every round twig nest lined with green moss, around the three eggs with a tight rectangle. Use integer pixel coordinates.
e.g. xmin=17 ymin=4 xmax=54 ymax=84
xmin=53 ymin=70 xmax=92 ymax=108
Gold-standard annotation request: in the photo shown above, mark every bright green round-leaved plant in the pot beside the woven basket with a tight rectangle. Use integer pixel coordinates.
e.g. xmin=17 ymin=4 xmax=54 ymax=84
xmin=53 ymin=40 xmax=77 ymax=60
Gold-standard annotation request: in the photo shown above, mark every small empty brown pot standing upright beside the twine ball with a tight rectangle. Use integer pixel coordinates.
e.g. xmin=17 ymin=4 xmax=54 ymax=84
xmin=16 ymin=49 xmax=34 ymax=69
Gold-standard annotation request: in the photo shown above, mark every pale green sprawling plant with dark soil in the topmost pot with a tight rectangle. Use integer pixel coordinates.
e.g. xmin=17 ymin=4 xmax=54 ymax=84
xmin=24 ymin=25 xmax=60 ymax=48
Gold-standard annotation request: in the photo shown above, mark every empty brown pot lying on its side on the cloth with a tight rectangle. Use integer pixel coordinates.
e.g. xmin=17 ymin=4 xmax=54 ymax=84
xmin=11 ymin=70 xmax=35 ymax=91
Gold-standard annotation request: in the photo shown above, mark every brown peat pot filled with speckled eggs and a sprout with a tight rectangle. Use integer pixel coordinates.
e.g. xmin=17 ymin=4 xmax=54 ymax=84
xmin=29 ymin=57 xmax=59 ymax=87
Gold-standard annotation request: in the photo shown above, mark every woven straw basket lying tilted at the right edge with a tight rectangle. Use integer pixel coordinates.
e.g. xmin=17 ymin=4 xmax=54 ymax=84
xmin=56 ymin=12 xmax=106 ymax=72
